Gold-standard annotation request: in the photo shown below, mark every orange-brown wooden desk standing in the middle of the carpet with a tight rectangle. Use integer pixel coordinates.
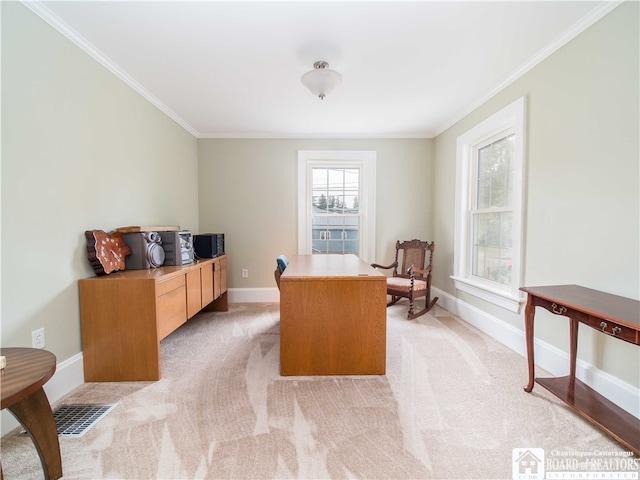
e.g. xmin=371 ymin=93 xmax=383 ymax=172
xmin=280 ymin=255 xmax=387 ymax=375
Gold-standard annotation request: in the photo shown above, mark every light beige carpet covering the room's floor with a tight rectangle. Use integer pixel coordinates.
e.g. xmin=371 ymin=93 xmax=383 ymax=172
xmin=2 ymin=302 xmax=624 ymax=480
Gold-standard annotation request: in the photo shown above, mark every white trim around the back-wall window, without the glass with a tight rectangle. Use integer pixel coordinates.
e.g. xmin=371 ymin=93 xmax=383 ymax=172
xmin=298 ymin=150 xmax=376 ymax=263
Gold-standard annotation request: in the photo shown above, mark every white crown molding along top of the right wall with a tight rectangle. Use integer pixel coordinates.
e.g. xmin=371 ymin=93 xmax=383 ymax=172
xmin=432 ymin=0 xmax=624 ymax=138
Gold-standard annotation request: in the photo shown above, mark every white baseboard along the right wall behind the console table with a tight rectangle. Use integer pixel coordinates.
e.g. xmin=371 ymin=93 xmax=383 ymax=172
xmin=432 ymin=288 xmax=640 ymax=418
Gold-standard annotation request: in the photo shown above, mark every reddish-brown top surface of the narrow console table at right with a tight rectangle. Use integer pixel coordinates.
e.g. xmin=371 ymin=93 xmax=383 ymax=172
xmin=520 ymin=285 xmax=640 ymax=330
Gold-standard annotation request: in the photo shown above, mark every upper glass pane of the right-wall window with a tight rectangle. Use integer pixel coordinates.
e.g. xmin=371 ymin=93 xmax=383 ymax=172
xmin=476 ymin=134 xmax=515 ymax=208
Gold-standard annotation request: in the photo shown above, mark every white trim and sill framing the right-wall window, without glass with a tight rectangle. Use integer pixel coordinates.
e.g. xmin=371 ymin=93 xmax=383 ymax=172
xmin=450 ymin=97 xmax=526 ymax=313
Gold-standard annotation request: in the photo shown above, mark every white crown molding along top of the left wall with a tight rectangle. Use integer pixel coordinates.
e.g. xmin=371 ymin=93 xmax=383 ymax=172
xmin=20 ymin=0 xmax=200 ymax=138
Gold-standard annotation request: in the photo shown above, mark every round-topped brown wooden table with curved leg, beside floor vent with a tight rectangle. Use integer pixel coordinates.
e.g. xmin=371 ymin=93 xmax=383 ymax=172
xmin=0 ymin=348 xmax=62 ymax=479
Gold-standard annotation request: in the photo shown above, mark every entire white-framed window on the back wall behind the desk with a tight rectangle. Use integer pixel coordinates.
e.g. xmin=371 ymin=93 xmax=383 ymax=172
xmin=298 ymin=150 xmax=376 ymax=262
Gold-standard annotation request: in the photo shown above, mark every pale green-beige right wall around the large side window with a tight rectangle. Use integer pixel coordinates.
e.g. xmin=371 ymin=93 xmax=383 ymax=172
xmin=433 ymin=2 xmax=640 ymax=386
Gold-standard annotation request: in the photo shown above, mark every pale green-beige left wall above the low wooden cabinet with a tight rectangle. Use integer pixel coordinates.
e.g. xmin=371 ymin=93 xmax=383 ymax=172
xmin=1 ymin=2 xmax=198 ymax=362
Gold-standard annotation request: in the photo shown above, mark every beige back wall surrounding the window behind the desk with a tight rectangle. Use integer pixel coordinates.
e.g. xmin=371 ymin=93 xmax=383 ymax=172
xmin=198 ymin=139 xmax=433 ymax=288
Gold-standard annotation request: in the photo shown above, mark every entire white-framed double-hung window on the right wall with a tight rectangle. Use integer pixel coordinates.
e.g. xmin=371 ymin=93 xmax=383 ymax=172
xmin=451 ymin=97 xmax=526 ymax=312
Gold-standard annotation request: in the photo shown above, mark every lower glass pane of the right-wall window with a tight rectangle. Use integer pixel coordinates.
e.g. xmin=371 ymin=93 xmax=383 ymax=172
xmin=471 ymin=212 xmax=513 ymax=285
